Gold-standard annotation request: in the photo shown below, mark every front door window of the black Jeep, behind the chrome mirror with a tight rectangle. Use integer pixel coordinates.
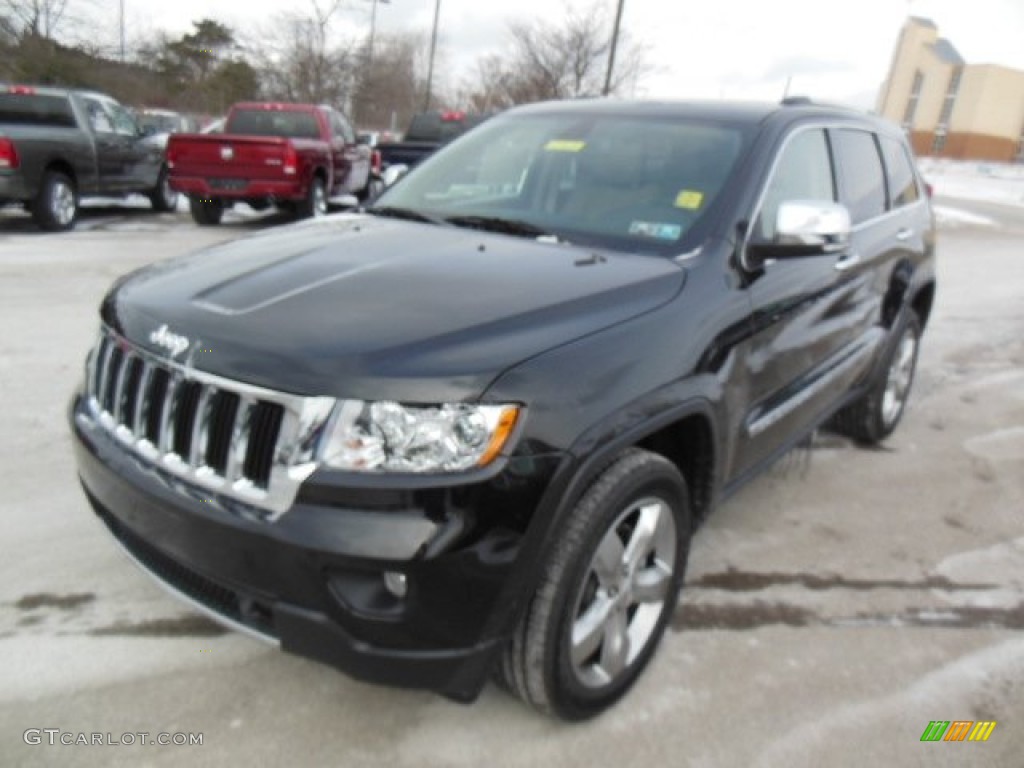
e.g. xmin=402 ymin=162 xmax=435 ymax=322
xmin=755 ymin=130 xmax=836 ymax=240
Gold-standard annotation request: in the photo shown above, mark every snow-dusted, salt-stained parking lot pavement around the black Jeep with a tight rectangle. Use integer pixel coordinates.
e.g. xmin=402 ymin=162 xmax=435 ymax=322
xmin=0 ymin=202 xmax=1024 ymax=768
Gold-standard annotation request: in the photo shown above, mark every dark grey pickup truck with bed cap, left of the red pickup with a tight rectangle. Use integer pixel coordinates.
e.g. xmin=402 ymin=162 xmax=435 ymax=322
xmin=0 ymin=85 xmax=177 ymax=231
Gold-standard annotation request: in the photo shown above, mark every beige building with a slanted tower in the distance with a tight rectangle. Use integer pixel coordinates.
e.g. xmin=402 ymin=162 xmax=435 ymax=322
xmin=878 ymin=16 xmax=1024 ymax=162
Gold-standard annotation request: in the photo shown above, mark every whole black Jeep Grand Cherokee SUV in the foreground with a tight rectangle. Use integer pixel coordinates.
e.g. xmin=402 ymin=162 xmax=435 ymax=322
xmin=71 ymin=100 xmax=935 ymax=719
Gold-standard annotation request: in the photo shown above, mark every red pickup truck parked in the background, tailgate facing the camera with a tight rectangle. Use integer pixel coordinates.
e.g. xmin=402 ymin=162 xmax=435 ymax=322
xmin=167 ymin=102 xmax=380 ymax=226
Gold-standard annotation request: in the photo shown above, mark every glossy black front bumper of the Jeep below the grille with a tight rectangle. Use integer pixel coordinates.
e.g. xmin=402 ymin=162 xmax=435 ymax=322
xmin=70 ymin=396 xmax=557 ymax=700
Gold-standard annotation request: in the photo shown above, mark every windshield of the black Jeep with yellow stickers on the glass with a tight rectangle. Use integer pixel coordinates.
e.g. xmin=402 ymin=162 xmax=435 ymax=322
xmin=371 ymin=114 xmax=744 ymax=254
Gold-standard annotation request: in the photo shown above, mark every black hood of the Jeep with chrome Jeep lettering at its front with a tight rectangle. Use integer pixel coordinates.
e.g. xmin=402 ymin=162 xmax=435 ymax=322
xmin=102 ymin=214 xmax=684 ymax=402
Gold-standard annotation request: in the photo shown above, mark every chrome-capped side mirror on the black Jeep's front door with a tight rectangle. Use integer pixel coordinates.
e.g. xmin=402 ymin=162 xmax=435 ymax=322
xmin=746 ymin=200 xmax=852 ymax=261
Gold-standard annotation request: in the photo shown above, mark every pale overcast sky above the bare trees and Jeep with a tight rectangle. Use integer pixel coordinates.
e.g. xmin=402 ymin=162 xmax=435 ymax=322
xmin=96 ymin=0 xmax=1024 ymax=108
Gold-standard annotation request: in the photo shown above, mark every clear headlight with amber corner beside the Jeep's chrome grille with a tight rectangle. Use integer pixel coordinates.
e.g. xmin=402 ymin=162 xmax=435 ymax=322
xmin=319 ymin=400 xmax=519 ymax=472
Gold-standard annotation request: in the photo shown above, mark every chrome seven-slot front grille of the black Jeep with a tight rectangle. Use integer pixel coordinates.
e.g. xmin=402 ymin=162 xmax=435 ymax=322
xmin=80 ymin=328 xmax=335 ymax=519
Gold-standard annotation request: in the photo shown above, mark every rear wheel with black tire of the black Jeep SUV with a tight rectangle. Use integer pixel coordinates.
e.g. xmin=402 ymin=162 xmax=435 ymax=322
xmin=828 ymin=309 xmax=921 ymax=445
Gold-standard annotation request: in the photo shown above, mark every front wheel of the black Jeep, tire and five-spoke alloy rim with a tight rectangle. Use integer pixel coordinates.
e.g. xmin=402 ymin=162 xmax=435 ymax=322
xmin=497 ymin=449 xmax=691 ymax=720
